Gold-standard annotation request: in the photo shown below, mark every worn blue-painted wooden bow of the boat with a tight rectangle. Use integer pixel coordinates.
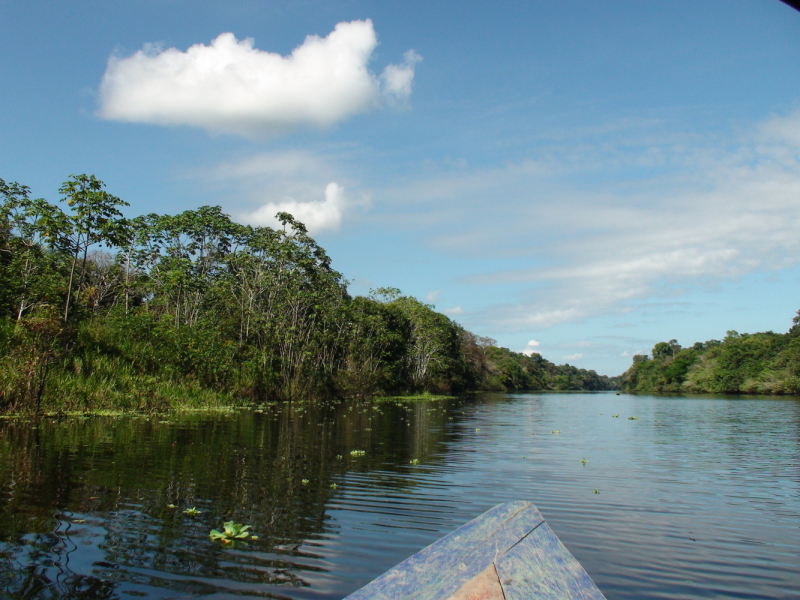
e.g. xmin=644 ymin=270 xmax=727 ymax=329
xmin=345 ymin=502 xmax=604 ymax=600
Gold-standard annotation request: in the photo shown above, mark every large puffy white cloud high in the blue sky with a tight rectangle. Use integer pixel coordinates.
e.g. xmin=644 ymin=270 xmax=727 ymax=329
xmin=98 ymin=19 xmax=421 ymax=136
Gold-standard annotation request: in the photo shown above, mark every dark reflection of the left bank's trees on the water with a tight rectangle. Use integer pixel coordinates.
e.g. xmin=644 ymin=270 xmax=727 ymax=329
xmin=0 ymin=402 xmax=478 ymax=598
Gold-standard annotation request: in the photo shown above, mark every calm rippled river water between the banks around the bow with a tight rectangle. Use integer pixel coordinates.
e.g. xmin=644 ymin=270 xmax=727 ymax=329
xmin=0 ymin=393 xmax=800 ymax=600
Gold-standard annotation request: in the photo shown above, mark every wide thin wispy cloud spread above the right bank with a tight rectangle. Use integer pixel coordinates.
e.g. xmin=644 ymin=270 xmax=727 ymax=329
xmin=378 ymin=111 xmax=800 ymax=332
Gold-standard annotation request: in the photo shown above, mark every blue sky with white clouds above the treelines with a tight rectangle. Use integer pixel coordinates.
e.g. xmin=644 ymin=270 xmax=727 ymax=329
xmin=0 ymin=0 xmax=800 ymax=375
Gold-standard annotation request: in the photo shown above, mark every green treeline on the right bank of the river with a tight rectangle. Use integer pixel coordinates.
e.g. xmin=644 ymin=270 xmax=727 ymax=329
xmin=622 ymin=311 xmax=800 ymax=395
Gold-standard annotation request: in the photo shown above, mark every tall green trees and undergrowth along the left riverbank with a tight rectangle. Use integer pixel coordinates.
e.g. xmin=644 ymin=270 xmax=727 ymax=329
xmin=0 ymin=175 xmax=612 ymax=411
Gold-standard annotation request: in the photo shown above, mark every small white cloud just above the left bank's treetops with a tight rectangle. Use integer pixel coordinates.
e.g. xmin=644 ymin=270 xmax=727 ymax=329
xmin=243 ymin=181 xmax=356 ymax=234
